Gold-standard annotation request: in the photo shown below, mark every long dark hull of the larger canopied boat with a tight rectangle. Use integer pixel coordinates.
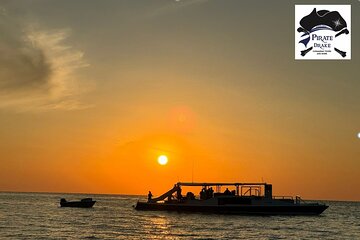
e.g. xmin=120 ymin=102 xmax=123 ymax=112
xmin=135 ymin=202 xmax=328 ymax=215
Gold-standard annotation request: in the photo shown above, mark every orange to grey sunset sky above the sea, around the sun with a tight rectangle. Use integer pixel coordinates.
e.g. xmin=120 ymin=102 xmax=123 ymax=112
xmin=0 ymin=0 xmax=360 ymax=201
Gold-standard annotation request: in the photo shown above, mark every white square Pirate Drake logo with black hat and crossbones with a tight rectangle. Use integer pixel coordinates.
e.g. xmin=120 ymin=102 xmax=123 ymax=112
xmin=295 ymin=5 xmax=351 ymax=60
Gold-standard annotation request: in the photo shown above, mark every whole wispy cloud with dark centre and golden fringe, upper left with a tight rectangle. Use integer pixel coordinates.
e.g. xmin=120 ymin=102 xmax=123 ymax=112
xmin=0 ymin=8 xmax=88 ymax=111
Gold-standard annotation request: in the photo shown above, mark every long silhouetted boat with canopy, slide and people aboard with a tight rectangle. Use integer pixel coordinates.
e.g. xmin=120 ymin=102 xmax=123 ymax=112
xmin=134 ymin=182 xmax=328 ymax=215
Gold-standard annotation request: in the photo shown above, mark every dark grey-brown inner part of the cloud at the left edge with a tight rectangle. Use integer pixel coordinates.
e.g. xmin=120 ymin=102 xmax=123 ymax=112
xmin=0 ymin=10 xmax=51 ymax=91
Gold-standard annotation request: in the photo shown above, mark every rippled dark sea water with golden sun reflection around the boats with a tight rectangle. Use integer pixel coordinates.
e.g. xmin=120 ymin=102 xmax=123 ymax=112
xmin=0 ymin=193 xmax=360 ymax=239
